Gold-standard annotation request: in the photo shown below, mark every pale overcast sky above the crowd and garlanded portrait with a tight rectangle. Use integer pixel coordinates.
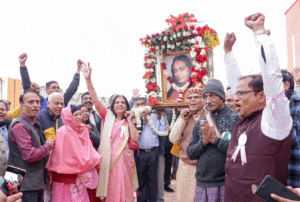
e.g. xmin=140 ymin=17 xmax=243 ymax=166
xmin=0 ymin=0 xmax=295 ymax=99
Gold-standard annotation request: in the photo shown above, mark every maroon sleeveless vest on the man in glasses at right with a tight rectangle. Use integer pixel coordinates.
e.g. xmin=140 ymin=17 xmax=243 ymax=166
xmin=225 ymin=111 xmax=292 ymax=202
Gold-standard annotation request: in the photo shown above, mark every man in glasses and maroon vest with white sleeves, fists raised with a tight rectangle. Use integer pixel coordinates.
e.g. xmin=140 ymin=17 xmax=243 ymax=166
xmin=224 ymin=13 xmax=293 ymax=201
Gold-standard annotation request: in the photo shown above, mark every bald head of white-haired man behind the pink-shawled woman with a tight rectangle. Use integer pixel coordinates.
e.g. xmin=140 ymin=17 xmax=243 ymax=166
xmin=47 ymin=92 xmax=64 ymax=116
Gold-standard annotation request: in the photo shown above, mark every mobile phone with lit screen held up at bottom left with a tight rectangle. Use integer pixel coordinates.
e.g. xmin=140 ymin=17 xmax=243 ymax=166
xmin=2 ymin=165 xmax=27 ymax=196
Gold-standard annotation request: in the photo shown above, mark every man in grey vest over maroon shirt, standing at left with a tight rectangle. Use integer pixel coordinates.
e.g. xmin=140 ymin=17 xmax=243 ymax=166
xmin=8 ymin=89 xmax=54 ymax=202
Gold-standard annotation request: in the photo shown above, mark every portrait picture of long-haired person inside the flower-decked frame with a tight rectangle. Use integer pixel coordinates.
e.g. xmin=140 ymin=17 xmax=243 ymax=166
xmin=166 ymin=54 xmax=192 ymax=100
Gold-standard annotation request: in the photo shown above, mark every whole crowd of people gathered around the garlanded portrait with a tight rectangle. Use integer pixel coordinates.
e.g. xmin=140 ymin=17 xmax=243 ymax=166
xmin=0 ymin=13 xmax=300 ymax=202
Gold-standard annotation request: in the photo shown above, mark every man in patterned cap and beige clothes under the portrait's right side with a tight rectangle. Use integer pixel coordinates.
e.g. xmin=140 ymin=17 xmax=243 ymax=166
xmin=169 ymin=87 xmax=207 ymax=202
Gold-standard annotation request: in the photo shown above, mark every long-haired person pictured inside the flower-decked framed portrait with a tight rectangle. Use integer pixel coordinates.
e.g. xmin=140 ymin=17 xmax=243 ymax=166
xmin=167 ymin=55 xmax=192 ymax=99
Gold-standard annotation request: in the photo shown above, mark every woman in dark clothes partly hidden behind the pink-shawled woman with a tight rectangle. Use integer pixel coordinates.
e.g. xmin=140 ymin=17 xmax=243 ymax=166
xmin=79 ymin=105 xmax=100 ymax=150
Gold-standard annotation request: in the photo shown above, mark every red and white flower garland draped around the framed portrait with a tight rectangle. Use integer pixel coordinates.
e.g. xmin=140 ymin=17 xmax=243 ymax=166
xmin=140 ymin=13 xmax=220 ymax=106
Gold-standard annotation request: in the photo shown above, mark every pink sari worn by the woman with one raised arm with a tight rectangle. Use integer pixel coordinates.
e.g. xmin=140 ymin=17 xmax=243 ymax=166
xmin=105 ymin=120 xmax=135 ymax=202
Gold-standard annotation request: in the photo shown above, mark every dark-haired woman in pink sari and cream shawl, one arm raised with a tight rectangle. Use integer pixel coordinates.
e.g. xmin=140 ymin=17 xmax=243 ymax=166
xmin=82 ymin=65 xmax=139 ymax=202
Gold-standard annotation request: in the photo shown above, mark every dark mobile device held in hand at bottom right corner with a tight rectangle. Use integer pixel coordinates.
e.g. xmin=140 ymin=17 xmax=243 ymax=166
xmin=253 ymin=175 xmax=300 ymax=202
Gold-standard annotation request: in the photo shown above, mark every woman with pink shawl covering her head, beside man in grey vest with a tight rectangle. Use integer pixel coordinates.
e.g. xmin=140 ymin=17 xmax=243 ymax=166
xmin=46 ymin=106 xmax=102 ymax=202
